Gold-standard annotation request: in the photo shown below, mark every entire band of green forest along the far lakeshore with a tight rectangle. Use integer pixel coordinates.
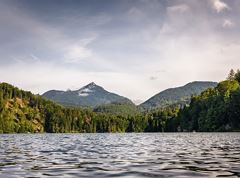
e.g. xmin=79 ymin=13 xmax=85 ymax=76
xmin=0 ymin=70 xmax=240 ymax=133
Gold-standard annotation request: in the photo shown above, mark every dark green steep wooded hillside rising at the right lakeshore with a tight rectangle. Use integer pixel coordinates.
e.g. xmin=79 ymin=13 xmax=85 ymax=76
xmin=168 ymin=70 xmax=240 ymax=131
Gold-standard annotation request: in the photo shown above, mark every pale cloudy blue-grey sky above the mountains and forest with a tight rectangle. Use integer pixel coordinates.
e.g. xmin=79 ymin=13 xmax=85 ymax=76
xmin=0 ymin=0 xmax=240 ymax=103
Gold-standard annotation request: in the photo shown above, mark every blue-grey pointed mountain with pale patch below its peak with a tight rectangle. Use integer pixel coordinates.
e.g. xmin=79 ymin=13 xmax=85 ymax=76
xmin=42 ymin=82 xmax=132 ymax=107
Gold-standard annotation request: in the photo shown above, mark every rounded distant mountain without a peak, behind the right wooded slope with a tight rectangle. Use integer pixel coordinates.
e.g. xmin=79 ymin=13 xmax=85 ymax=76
xmin=140 ymin=81 xmax=217 ymax=110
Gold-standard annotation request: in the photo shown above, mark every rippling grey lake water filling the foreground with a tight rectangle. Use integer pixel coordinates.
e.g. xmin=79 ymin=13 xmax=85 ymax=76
xmin=0 ymin=133 xmax=240 ymax=178
